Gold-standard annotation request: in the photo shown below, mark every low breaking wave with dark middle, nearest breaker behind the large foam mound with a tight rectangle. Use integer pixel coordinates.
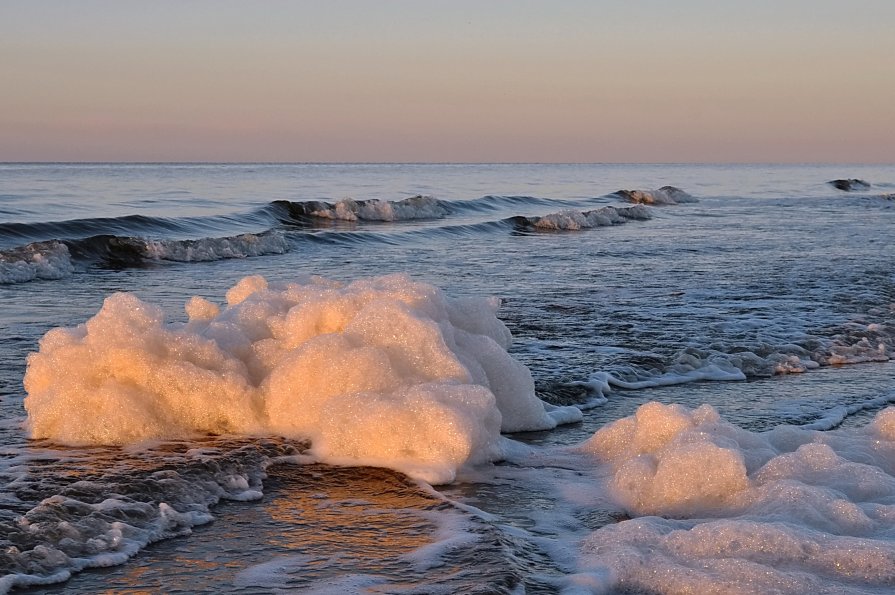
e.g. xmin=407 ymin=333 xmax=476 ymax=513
xmin=0 ymin=231 xmax=288 ymax=284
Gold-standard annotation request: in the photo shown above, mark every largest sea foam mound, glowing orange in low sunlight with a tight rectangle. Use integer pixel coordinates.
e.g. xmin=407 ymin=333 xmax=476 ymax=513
xmin=25 ymin=275 xmax=581 ymax=483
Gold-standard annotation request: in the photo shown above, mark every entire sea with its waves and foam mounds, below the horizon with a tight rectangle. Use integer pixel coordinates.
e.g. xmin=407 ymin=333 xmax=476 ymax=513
xmin=0 ymin=164 xmax=895 ymax=593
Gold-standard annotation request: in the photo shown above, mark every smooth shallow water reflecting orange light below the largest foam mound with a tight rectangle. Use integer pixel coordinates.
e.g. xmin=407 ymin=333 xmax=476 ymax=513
xmin=19 ymin=464 xmax=521 ymax=594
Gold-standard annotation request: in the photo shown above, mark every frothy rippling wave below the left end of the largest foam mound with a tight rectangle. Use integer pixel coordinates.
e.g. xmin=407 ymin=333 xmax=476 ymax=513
xmin=0 ymin=439 xmax=306 ymax=593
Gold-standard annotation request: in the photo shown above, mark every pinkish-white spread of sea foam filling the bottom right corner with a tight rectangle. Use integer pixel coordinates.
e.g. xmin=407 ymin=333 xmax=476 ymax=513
xmin=581 ymin=403 xmax=895 ymax=593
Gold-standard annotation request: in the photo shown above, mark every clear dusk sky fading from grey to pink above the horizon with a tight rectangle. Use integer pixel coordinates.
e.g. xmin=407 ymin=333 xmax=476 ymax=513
xmin=0 ymin=0 xmax=895 ymax=163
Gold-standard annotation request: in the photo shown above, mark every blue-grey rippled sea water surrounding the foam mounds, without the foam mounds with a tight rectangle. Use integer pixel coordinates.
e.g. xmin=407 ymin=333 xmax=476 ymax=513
xmin=0 ymin=164 xmax=895 ymax=592
